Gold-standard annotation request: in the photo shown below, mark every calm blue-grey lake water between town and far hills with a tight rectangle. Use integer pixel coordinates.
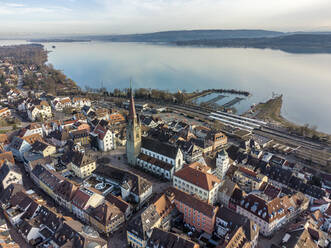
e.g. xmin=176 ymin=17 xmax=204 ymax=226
xmin=0 ymin=41 xmax=331 ymax=133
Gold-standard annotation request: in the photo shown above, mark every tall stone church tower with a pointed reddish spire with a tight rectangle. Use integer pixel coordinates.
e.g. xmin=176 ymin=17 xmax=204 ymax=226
xmin=126 ymin=87 xmax=141 ymax=165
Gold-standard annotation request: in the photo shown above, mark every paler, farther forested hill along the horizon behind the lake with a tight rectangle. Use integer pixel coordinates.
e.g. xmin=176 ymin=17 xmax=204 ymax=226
xmin=84 ymin=30 xmax=284 ymax=42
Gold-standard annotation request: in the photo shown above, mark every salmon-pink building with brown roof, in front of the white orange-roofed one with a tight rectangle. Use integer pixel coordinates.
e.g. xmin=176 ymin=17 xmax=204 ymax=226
xmin=169 ymin=188 xmax=218 ymax=234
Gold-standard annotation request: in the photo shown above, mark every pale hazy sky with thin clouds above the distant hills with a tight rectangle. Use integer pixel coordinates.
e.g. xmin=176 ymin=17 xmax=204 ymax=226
xmin=0 ymin=0 xmax=331 ymax=34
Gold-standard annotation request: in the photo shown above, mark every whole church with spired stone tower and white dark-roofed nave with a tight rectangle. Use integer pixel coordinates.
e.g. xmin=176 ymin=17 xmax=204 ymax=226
xmin=126 ymin=89 xmax=184 ymax=180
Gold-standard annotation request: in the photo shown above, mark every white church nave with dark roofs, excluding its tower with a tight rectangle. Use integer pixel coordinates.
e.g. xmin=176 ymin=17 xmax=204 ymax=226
xmin=136 ymin=138 xmax=184 ymax=180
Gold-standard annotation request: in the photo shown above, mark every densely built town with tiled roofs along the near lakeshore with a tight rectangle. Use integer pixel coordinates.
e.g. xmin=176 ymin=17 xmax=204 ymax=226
xmin=0 ymin=42 xmax=331 ymax=248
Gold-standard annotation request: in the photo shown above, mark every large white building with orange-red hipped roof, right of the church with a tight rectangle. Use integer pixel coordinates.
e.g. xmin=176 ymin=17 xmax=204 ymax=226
xmin=173 ymin=162 xmax=221 ymax=204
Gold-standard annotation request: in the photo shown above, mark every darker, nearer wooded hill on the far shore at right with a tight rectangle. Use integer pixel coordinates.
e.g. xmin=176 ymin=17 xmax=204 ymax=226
xmin=174 ymin=34 xmax=331 ymax=53
